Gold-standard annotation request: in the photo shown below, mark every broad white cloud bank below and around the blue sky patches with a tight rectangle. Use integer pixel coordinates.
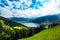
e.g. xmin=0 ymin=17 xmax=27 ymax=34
xmin=0 ymin=0 xmax=60 ymax=18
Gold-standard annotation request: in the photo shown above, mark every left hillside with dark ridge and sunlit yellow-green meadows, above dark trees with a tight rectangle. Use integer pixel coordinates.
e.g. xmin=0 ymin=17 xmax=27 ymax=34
xmin=0 ymin=16 xmax=26 ymax=30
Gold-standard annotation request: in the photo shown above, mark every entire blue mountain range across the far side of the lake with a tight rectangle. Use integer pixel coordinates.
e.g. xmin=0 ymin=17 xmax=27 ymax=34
xmin=8 ymin=14 xmax=60 ymax=23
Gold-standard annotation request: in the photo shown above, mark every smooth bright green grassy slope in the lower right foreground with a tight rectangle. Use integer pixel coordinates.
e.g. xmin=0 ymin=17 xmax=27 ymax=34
xmin=19 ymin=25 xmax=60 ymax=40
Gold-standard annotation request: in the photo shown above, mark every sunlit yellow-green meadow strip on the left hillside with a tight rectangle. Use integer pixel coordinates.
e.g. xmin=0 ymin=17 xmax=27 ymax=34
xmin=0 ymin=20 xmax=26 ymax=31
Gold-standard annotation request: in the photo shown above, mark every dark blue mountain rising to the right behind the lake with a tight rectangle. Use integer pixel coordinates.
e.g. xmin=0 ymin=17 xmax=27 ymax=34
xmin=31 ymin=14 xmax=60 ymax=23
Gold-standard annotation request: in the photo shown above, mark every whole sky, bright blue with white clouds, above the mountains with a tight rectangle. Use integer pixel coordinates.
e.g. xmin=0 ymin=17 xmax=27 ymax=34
xmin=0 ymin=0 xmax=60 ymax=18
